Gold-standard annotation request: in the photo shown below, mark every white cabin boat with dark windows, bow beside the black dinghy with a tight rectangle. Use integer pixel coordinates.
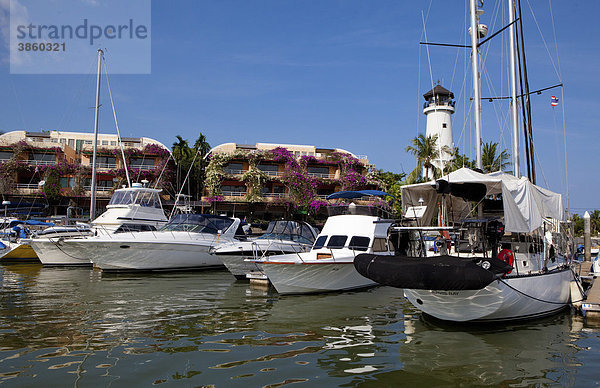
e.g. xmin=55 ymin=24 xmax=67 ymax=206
xmin=256 ymin=203 xmax=394 ymax=294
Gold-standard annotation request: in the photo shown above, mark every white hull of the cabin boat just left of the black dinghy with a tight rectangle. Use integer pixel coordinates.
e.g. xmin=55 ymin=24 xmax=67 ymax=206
xmin=259 ymin=261 xmax=377 ymax=294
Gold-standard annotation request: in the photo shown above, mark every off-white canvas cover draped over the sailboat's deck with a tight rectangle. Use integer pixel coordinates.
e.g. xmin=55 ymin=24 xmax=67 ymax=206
xmin=402 ymin=168 xmax=564 ymax=233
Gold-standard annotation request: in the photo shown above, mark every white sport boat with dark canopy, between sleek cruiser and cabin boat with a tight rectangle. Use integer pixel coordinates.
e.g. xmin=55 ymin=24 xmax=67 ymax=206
xmin=212 ymin=220 xmax=319 ymax=280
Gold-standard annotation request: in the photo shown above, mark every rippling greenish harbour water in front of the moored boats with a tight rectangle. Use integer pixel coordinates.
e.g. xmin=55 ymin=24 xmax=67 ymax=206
xmin=0 ymin=265 xmax=600 ymax=387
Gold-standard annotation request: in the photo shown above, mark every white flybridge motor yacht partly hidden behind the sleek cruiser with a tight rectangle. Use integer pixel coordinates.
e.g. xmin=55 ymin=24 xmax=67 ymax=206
xmin=28 ymin=183 xmax=167 ymax=266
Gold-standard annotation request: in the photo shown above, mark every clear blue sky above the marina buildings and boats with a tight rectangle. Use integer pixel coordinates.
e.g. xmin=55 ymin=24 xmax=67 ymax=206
xmin=0 ymin=0 xmax=600 ymax=212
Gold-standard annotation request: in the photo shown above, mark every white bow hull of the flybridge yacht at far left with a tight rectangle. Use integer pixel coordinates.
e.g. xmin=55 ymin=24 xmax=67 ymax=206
xmin=29 ymin=238 xmax=92 ymax=266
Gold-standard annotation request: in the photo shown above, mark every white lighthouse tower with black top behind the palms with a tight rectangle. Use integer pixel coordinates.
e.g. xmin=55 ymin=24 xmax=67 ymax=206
xmin=423 ymin=85 xmax=454 ymax=177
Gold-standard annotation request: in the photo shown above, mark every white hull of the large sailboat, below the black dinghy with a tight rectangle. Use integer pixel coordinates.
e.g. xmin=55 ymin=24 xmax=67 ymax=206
xmin=404 ymin=269 xmax=572 ymax=322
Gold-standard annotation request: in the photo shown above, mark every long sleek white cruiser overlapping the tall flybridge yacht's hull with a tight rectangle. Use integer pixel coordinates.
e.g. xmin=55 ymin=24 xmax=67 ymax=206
xmin=82 ymin=214 xmax=245 ymax=271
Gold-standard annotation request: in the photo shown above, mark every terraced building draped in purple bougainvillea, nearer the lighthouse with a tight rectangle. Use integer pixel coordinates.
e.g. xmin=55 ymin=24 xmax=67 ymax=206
xmin=203 ymin=143 xmax=380 ymax=220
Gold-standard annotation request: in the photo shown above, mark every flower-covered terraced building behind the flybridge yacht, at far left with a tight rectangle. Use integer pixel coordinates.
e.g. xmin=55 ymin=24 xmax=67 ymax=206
xmin=0 ymin=131 xmax=171 ymax=214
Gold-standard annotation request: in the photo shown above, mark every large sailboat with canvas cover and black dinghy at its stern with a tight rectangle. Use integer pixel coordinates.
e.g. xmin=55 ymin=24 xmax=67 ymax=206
xmin=354 ymin=0 xmax=574 ymax=322
